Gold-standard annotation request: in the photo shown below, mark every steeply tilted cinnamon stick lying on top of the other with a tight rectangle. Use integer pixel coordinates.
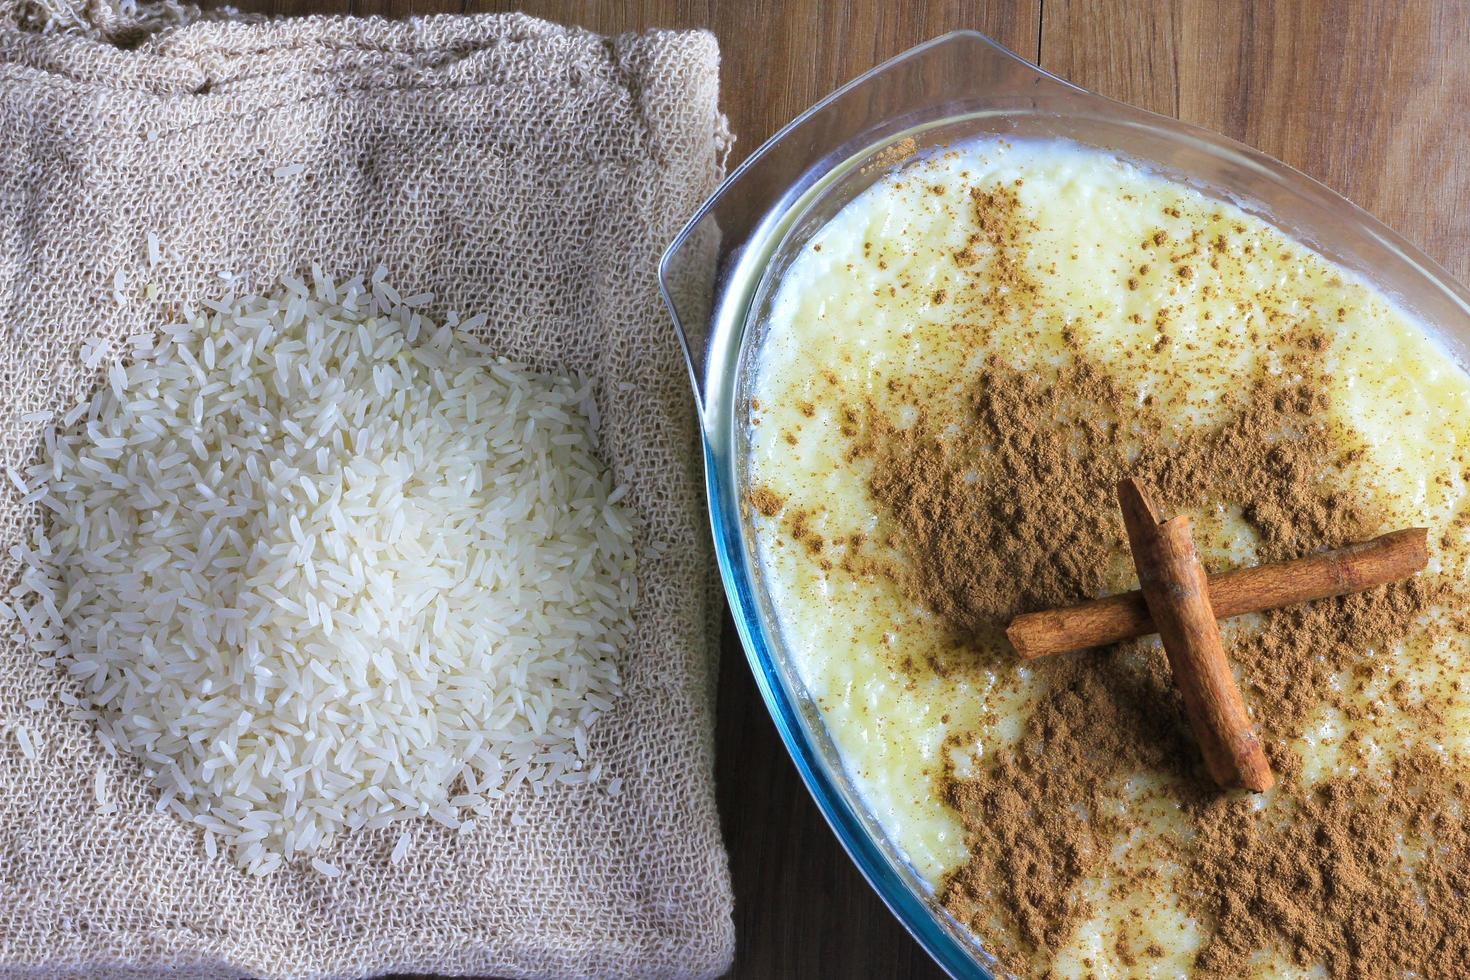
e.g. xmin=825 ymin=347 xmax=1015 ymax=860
xmin=1117 ymin=480 xmax=1276 ymax=793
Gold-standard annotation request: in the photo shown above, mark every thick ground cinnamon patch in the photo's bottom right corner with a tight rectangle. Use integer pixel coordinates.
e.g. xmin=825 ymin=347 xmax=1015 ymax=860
xmin=1183 ymin=752 xmax=1470 ymax=979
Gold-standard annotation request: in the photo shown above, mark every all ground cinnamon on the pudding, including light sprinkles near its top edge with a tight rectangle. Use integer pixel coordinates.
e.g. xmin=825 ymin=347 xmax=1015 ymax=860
xmin=748 ymin=174 xmax=1470 ymax=979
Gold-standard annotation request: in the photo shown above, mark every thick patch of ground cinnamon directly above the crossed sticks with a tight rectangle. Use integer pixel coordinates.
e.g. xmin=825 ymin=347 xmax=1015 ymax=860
xmin=851 ymin=357 xmax=1370 ymax=633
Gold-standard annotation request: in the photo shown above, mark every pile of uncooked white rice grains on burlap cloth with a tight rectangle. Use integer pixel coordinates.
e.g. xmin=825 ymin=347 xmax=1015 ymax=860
xmin=0 ymin=269 xmax=637 ymax=874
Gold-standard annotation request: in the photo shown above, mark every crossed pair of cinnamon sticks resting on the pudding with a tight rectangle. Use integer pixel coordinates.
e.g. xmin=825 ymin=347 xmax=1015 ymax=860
xmin=1005 ymin=480 xmax=1429 ymax=792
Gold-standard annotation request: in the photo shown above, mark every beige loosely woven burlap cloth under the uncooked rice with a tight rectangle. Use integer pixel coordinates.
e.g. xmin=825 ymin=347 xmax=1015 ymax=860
xmin=0 ymin=9 xmax=732 ymax=976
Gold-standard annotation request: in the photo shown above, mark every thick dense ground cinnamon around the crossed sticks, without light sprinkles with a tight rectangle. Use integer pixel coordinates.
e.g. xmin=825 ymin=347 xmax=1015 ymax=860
xmin=845 ymin=354 xmax=1470 ymax=977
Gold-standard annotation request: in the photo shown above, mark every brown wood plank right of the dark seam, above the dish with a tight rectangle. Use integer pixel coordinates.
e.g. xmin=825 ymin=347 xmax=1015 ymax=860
xmin=1041 ymin=0 xmax=1470 ymax=279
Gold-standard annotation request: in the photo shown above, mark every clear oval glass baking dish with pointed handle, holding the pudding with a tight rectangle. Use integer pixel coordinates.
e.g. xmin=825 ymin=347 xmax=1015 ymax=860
xmin=659 ymin=31 xmax=1470 ymax=977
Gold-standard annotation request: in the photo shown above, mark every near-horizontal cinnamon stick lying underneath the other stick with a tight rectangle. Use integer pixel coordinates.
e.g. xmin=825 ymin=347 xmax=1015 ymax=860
xmin=1005 ymin=527 xmax=1429 ymax=660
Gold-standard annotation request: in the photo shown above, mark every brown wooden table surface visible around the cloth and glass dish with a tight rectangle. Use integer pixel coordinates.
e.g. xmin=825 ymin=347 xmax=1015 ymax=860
xmin=217 ymin=0 xmax=1470 ymax=980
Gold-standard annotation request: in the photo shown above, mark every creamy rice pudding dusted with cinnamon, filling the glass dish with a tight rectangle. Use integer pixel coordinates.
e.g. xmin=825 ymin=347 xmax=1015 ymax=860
xmin=745 ymin=140 xmax=1470 ymax=977
